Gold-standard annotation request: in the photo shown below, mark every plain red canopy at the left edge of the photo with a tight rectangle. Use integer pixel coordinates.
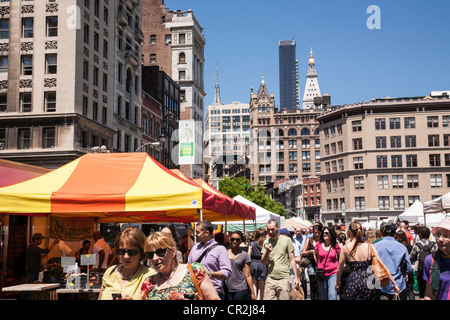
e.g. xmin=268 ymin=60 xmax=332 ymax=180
xmin=0 ymin=159 xmax=50 ymax=187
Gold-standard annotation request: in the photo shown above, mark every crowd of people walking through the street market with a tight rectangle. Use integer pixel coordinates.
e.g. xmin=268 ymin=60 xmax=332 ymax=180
xmin=29 ymin=218 xmax=450 ymax=300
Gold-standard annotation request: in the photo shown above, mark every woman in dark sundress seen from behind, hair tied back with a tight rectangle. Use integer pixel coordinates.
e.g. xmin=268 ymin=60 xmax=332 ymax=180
xmin=336 ymin=222 xmax=398 ymax=300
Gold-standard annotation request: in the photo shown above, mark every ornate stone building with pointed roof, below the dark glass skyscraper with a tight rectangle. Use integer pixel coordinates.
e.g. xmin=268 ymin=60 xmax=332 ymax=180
xmin=250 ymin=78 xmax=329 ymax=184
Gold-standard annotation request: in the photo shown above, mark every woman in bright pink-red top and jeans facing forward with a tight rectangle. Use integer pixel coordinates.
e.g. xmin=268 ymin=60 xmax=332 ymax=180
xmin=315 ymin=227 xmax=341 ymax=300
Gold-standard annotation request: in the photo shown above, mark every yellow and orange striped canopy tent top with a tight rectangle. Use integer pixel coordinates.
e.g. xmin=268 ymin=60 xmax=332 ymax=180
xmin=0 ymin=153 xmax=253 ymax=223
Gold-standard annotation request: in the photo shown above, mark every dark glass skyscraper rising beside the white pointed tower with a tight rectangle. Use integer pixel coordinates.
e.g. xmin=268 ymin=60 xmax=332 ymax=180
xmin=278 ymin=39 xmax=300 ymax=110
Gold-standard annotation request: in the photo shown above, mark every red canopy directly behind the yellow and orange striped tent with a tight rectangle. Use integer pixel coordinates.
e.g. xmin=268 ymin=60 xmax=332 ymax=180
xmin=170 ymin=169 xmax=256 ymax=221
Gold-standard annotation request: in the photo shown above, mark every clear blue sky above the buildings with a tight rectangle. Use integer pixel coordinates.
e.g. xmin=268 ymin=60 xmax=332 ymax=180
xmin=165 ymin=0 xmax=450 ymax=109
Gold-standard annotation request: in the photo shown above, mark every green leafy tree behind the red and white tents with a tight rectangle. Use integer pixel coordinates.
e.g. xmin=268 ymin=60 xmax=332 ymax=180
xmin=219 ymin=177 xmax=287 ymax=216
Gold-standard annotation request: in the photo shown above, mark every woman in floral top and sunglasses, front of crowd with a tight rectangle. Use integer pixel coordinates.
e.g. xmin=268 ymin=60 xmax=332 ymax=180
xmin=141 ymin=232 xmax=220 ymax=300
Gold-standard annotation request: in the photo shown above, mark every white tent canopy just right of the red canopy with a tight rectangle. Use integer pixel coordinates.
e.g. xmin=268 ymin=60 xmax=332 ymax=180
xmin=212 ymin=195 xmax=280 ymax=231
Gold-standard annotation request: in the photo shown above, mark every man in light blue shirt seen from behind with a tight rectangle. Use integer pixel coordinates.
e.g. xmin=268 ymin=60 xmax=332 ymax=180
xmin=374 ymin=222 xmax=412 ymax=300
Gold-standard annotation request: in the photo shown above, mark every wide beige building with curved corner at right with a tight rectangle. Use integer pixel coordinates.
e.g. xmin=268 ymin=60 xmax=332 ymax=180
xmin=317 ymin=91 xmax=450 ymax=226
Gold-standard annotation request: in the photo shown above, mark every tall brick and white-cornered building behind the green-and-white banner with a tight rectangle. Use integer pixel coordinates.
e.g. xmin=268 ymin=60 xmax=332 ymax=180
xmin=142 ymin=0 xmax=206 ymax=178
